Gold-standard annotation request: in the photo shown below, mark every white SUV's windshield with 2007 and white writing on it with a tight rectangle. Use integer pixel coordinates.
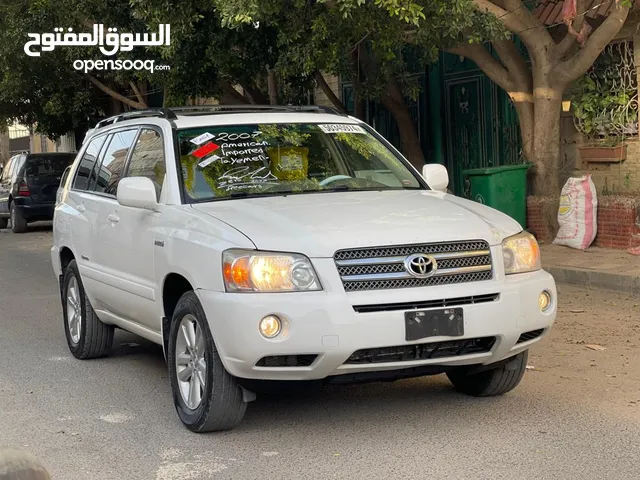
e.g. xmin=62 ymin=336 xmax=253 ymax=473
xmin=178 ymin=124 xmax=426 ymax=202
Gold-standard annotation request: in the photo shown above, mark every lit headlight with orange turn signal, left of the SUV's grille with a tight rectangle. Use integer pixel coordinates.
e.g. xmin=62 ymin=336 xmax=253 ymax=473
xmin=222 ymin=250 xmax=322 ymax=292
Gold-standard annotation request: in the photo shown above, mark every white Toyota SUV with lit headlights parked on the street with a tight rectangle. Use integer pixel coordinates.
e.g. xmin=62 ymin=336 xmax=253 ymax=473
xmin=51 ymin=106 xmax=557 ymax=432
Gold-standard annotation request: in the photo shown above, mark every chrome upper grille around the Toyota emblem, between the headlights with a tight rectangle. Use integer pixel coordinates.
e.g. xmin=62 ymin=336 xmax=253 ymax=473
xmin=334 ymin=240 xmax=493 ymax=292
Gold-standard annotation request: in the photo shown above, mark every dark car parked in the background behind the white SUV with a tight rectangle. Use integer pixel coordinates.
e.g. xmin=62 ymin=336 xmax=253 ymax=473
xmin=0 ymin=153 xmax=76 ymax=233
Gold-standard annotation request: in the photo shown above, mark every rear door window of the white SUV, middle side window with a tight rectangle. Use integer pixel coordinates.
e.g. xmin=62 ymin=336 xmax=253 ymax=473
xmin=92 ymin=129 xmax=138 ymax=195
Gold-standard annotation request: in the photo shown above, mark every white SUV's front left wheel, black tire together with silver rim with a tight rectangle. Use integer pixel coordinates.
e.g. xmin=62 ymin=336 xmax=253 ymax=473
xmin=167 ymin=292 xmax=247 ymax=433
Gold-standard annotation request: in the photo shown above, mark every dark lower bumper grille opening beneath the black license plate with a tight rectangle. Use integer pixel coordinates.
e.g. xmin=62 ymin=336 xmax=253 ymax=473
xmin=344 ymin=337 xmax=496 ymax=365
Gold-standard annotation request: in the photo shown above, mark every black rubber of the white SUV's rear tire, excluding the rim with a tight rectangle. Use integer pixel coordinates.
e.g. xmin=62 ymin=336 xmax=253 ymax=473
xmin=62 ymin=260 xmax=114 ymax=360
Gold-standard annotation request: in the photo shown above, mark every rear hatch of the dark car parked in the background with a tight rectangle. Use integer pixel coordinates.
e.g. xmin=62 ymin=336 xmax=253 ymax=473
xmin=23 ymin=154 xmax=75 ymax=204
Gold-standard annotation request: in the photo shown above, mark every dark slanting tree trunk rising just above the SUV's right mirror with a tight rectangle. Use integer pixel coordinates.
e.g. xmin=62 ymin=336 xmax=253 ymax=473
xmin=381 ymin=79 xmax=425 ymax=172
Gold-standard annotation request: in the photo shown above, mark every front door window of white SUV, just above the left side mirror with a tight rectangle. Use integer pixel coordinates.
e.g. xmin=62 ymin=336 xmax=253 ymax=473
xmin=127 ymin=128 xmax=165 ymax=201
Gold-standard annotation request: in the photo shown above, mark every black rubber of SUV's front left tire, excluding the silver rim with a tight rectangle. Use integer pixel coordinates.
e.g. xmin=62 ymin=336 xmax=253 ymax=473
xmin=167 ymin=292 xmax=247 ymax=433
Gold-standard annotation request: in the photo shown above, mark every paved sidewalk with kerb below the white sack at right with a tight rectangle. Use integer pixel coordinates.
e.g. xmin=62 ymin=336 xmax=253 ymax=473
xmin=540 ymin=245 xmax=640 ymax=296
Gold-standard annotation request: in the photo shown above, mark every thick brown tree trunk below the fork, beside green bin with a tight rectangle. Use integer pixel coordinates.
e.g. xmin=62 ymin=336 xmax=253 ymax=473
xmin=531 ymin=86 xmax=562 ymax=197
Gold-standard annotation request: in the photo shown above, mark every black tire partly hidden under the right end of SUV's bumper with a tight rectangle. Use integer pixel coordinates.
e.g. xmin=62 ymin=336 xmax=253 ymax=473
xmin=447 ymin=350 xmax=529 ymax=397
